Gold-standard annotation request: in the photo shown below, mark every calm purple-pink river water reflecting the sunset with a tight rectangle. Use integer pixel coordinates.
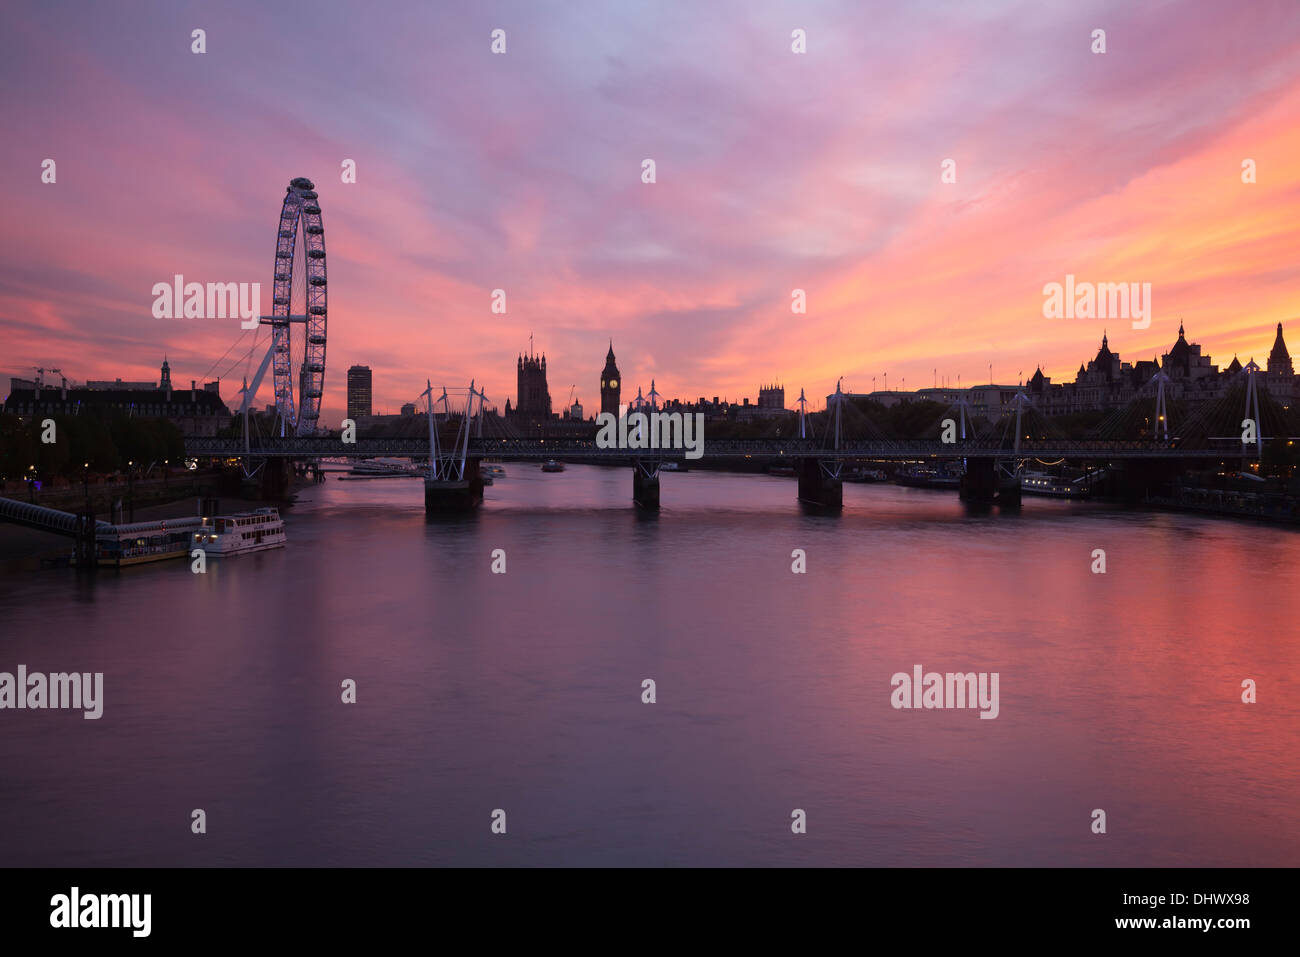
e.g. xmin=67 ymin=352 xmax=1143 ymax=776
xmin=0 ymin=464 xmax=1300 ymax=866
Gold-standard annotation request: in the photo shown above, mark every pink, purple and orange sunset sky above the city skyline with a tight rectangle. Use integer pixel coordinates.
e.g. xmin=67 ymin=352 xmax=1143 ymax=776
xmin=0 ymin=0 xmax=1300 ymax=425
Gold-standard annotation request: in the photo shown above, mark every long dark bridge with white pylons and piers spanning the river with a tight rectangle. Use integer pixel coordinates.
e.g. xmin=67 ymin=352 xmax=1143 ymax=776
xmin=185 ymin=363 xmax=1286 ymax=511
